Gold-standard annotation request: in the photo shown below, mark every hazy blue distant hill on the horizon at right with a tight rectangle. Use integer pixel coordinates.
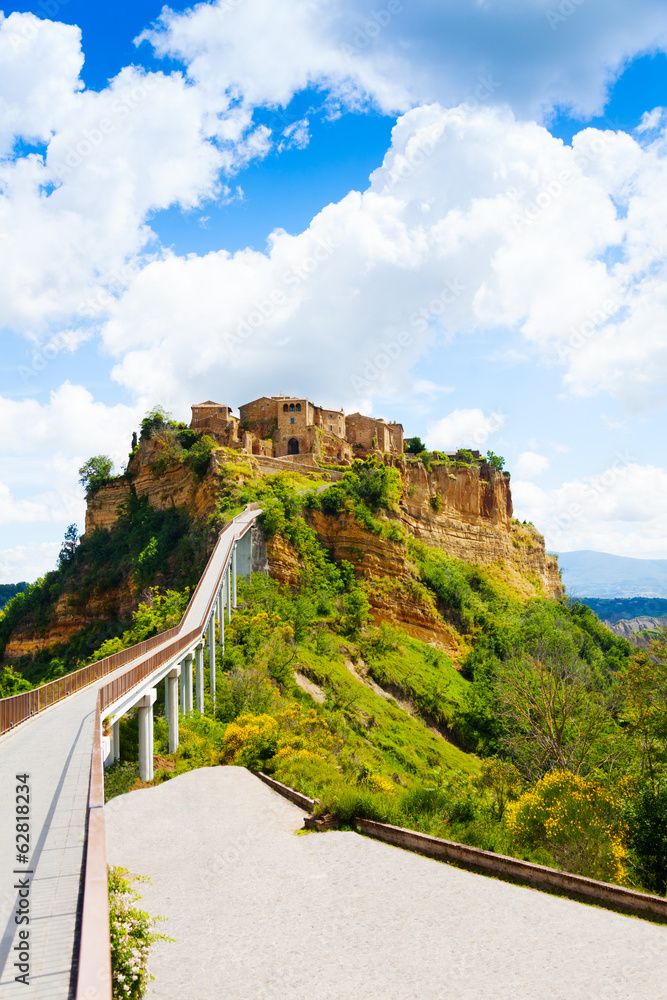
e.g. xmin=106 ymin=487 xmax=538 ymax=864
xmin=558 ymin=549 xmax=667 ymax=596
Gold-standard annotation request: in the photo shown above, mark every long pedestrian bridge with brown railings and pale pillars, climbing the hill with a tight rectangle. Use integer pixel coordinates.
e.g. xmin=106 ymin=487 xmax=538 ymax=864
xmin=0 ymin=504 xmax=265 ymax=1000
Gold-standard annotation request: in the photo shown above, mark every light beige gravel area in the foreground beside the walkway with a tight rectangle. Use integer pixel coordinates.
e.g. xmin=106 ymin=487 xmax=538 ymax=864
xmin=106 ymin=767 xmax=667 ymax=1000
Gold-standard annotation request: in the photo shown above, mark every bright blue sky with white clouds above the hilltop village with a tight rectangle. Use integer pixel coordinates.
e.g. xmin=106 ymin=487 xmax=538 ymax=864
xmin=0 ymin=0 xmax=667 ymax=580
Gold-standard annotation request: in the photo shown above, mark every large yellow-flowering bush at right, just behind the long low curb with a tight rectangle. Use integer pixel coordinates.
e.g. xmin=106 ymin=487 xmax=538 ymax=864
xmin=505 ymin=770 xmax=628 ymax=885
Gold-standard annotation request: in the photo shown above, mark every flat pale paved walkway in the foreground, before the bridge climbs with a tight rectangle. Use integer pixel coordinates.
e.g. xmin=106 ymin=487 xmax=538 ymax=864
xmin=0 ymin=685 xmax=97 ymax=1000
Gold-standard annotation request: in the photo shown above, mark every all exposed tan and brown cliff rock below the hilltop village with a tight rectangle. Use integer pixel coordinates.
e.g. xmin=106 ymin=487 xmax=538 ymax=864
xmin=5 ymin=440 xmax=562 ymax=659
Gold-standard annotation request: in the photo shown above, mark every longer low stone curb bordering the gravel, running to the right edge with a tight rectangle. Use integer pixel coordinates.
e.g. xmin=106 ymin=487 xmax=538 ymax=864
xmin=354 ymin=817 xmax=667 ymax=922
